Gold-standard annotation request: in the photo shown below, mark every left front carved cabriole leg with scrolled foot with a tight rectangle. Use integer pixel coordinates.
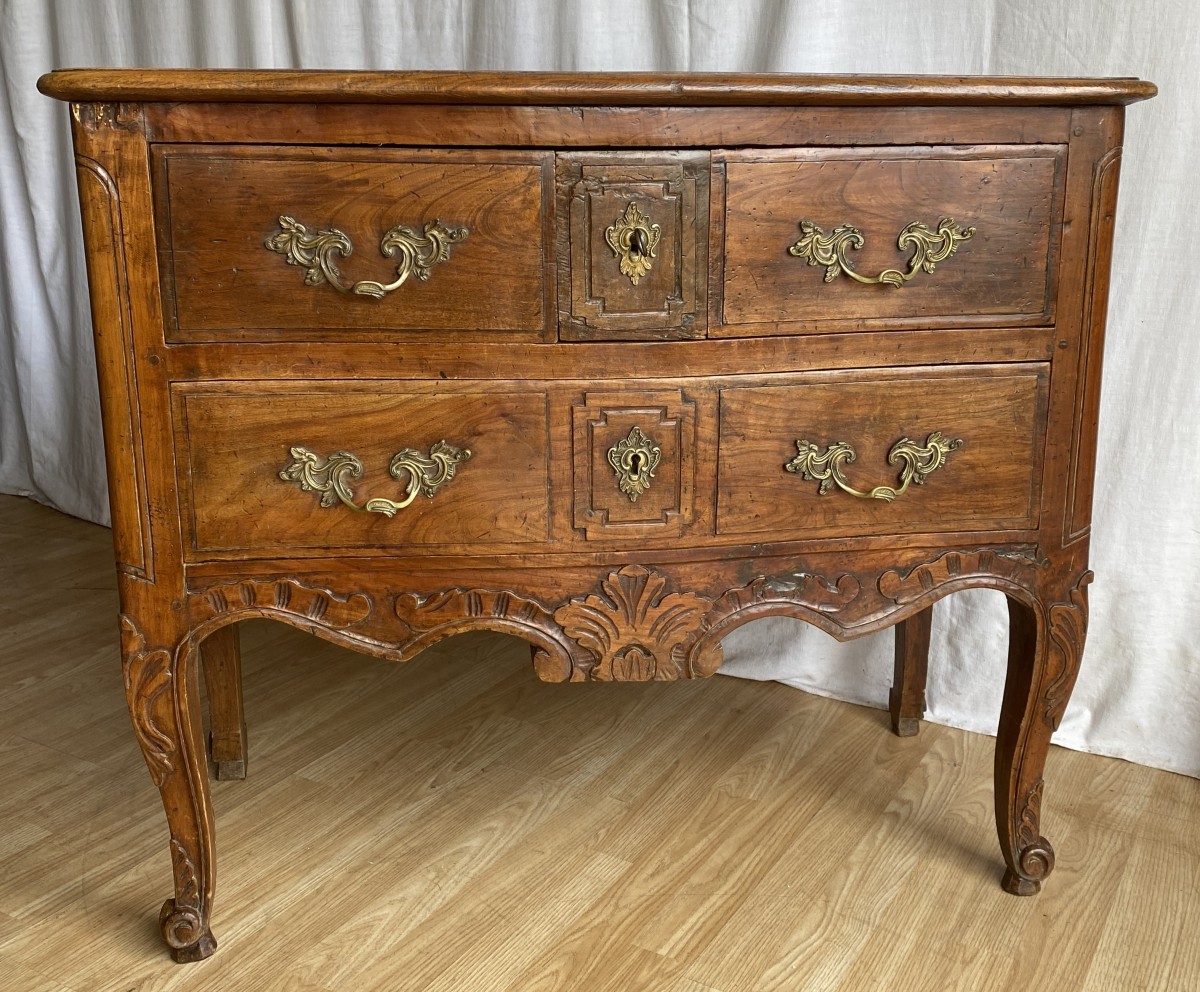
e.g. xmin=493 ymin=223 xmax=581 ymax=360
xmin=121 ymin=615 xmax=217 ymax=962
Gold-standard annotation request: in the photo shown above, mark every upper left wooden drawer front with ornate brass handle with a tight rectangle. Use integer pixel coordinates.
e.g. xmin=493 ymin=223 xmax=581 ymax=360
xmin=154 ymin=145 xmax=552 ymax=341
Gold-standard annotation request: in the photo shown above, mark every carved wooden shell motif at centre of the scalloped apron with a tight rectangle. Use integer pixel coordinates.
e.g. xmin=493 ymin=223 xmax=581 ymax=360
xmin=554 ymin=565 xmax=709 ymax=681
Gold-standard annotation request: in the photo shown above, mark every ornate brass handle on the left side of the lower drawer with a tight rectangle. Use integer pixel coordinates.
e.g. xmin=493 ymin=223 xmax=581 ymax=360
xmin=280 ymin=441 xmax=470 ymax=517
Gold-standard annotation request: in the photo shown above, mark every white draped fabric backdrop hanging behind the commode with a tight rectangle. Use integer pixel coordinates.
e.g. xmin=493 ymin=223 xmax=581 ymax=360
xmin=0 ymin=0 xmax=1200 ymax=776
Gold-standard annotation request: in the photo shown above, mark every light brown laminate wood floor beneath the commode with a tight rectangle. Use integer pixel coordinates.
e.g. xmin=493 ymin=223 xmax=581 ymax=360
xmin=0 ymin=497 xmax=1200 ymax=992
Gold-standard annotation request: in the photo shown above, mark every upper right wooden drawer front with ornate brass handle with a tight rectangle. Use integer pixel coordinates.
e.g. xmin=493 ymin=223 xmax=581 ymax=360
xmin=709 ymin=145 xmax=1064 ymax=336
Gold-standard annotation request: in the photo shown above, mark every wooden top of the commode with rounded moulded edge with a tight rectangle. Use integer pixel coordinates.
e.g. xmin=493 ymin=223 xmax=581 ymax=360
xmin=37 ymin=68 xmax=1158 ymax=107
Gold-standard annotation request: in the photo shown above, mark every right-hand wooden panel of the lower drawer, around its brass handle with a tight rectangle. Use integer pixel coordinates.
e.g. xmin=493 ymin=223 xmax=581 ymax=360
xmin=716 ymin=365 xmax=1049 ymax=539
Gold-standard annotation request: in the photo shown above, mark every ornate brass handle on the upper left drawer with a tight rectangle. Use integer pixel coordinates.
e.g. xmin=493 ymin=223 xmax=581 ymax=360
xmin=263 ymin=215 xmax=467 ymax=300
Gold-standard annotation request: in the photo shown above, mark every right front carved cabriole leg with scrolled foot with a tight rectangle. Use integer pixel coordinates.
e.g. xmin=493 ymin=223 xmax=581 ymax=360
xmin=996 ymin=571 xmax=1092 ymax=896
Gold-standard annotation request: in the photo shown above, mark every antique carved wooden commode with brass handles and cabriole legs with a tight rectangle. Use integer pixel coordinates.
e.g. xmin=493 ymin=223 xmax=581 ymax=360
xmin=40 ymin=70 xmax=1154 ymax=961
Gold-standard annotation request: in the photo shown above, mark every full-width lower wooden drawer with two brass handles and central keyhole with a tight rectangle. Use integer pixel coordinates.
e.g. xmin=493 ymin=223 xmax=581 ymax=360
xmin=173 ymin=363 xmax=1050 ymax=559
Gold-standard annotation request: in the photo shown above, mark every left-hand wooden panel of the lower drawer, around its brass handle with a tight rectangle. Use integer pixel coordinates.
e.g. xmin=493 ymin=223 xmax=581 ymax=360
xmin=174 ymin=383 xmax=550 ymax=554
